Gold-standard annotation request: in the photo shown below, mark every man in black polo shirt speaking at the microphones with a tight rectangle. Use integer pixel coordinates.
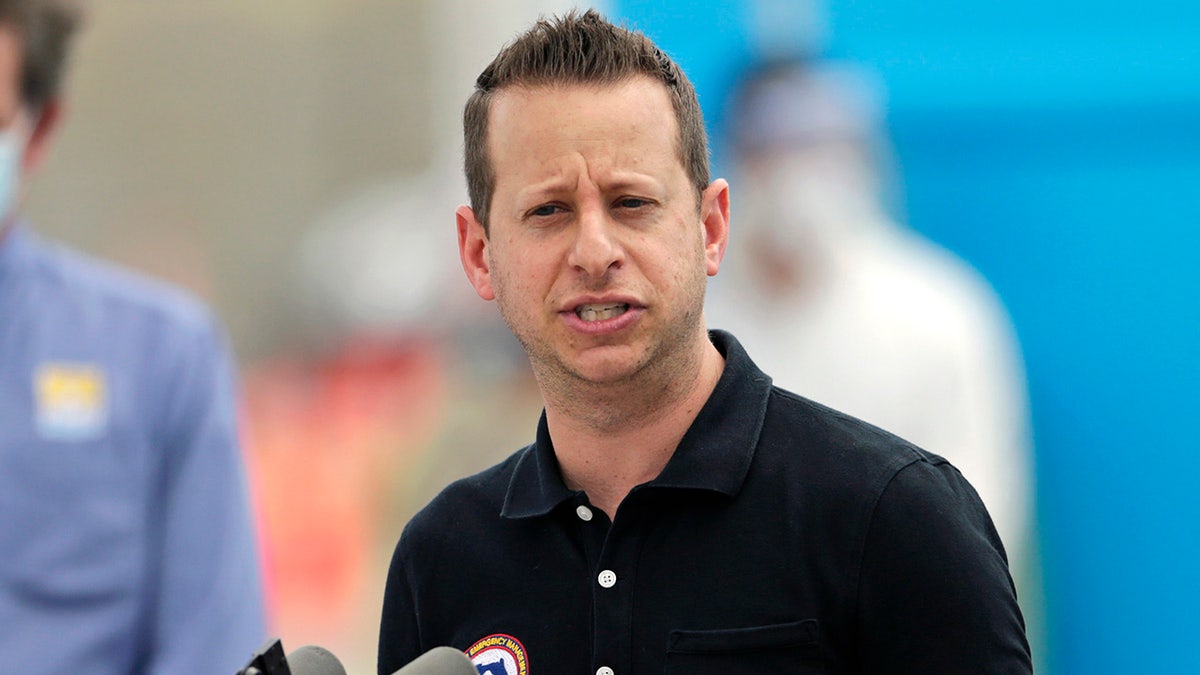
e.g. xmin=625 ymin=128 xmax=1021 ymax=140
xmin=378 ymin=12 xmax=1031 ymax=675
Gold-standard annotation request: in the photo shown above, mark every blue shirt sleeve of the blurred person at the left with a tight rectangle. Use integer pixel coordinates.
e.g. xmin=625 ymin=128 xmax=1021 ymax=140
xmin=144 ymin=323 xmax=265 ymax=675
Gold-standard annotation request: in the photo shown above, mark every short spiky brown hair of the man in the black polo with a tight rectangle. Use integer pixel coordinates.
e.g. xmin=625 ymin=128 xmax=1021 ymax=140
xmin=462 ymin=10 xmax=709 ymax=231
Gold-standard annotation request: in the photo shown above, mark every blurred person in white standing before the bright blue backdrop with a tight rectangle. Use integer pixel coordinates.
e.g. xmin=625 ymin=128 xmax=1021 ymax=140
xmin=709 ymin=61 xmax=1033 ymax=562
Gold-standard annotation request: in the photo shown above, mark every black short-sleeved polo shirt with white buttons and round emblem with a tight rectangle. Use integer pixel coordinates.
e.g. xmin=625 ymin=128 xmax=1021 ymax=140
xmin=379 ymin=331 xmax=1032 ymax=675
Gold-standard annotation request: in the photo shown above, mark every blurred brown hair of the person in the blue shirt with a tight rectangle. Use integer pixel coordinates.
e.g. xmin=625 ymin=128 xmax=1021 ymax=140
xmin=0 ymin=0 xmax=83 ymax=110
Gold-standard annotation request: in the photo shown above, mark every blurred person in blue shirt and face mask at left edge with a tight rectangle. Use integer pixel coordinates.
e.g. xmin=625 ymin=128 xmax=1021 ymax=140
xmin=0 ymin=0 xmax=264 ymax=674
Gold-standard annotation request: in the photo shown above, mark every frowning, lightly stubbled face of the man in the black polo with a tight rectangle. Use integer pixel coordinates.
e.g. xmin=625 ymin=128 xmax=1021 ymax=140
xmin=477 ymin=78 xmax=707 ymax=428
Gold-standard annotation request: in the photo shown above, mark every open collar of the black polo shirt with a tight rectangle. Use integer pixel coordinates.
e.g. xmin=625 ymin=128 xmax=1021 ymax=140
xmin=500 ymin=330 xmax=770 ymax=518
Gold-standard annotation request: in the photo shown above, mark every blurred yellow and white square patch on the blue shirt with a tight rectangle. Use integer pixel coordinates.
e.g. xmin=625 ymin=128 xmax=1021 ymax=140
xmin=34 ymin=363 xmax=108 ymax=441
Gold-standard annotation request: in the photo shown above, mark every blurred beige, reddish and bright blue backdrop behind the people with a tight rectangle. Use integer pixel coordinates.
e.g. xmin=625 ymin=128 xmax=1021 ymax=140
xmin=30 ymin=0 xmax=1200 ymax=675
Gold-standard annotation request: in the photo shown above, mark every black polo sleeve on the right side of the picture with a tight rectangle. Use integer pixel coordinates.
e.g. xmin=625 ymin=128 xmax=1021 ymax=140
xmin=858 ymin=454 xmax=1032 ymax=675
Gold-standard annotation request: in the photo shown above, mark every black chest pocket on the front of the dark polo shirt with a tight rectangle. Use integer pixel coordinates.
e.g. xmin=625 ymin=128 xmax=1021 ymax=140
xmin=666 ymin=619 xmax=828 ymax=675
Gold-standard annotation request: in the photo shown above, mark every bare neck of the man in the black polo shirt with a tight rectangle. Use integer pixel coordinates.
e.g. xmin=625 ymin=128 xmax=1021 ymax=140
xmin=545 ymin=338 xmax=725 ymax=518
